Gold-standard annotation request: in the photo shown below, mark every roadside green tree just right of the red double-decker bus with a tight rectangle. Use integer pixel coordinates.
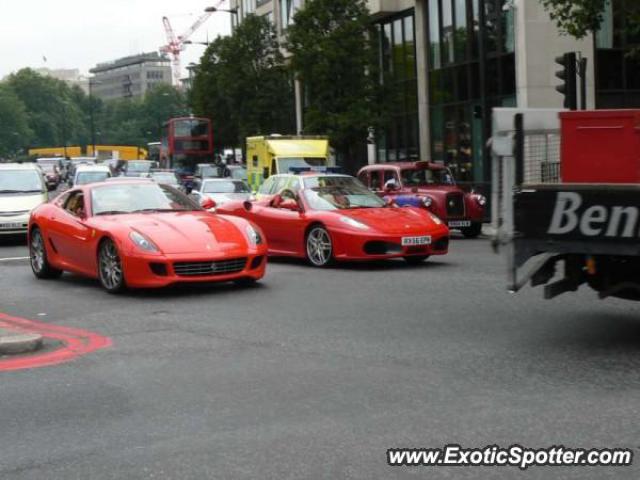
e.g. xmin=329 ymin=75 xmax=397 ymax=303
xmin=191 ymin=15 xmax=293 ymax=147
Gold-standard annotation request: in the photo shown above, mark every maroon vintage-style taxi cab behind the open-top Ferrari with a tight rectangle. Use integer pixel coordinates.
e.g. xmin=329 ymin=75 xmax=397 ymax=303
xmin=358 ymin=161 xmax=487 ymax=238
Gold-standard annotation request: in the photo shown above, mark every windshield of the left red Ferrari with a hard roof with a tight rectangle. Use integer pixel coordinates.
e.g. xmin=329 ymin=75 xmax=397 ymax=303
xmin=91 ymin=183 xmax=200 ymax=215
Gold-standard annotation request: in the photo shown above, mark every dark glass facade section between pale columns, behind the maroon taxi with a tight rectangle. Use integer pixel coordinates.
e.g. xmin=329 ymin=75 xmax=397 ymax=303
xmin=427 ymin=0 xmax=516 ymax=184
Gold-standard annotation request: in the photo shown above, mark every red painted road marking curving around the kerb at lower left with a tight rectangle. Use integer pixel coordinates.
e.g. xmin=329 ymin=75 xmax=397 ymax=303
xmin=0 ymin=313 xmax=112 ymax=371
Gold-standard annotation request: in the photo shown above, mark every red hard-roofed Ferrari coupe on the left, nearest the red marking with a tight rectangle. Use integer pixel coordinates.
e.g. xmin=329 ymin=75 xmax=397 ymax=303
xmin=29 ymin=180 xmax=267 ymax=292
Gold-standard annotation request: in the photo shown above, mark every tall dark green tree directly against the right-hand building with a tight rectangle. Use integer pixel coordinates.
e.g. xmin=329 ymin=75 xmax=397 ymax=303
xmin=286 ymin=0 xmax=381 ymax=171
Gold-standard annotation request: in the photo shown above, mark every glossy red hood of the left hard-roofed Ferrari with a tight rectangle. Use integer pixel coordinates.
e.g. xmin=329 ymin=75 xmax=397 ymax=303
xmin=102 ymin=212 xmax=248 ymax=255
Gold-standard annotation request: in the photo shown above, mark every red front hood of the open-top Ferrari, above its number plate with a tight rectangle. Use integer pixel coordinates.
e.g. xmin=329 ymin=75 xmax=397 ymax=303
xmin=340 ymin=207 xmax=435 ymax=234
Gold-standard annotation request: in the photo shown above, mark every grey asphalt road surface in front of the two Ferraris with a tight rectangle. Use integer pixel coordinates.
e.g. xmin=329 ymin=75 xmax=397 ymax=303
xmin=0 ymin=234 xmax=640 ymax=480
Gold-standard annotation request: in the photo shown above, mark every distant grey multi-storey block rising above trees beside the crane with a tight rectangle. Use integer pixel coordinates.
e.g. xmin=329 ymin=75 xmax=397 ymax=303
xmin=90 ymin=52 xmax=172 ymax=100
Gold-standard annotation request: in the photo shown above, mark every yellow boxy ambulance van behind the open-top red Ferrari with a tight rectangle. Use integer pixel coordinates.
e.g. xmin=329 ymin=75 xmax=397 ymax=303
xmin=247 ymin=135 xmax=332 ymax=191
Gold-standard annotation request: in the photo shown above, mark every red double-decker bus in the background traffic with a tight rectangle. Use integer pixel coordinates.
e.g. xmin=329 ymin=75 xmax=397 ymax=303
xmin=160 ymin=116 xmax=213 ymax=177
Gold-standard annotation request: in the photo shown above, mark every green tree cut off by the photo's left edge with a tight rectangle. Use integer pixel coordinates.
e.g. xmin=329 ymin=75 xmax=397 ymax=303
xmin=0 ymin=84 xmax=33 ymax=157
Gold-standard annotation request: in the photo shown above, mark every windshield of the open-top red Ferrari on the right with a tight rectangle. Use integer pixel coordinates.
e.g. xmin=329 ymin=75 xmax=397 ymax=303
xmin=303 ymin=176 xmax=385 ymax=210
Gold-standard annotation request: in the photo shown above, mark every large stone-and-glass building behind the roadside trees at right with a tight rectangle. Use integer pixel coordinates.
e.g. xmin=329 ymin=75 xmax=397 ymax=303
xmin=231 ymin=0 xmax=640 ymax=186
